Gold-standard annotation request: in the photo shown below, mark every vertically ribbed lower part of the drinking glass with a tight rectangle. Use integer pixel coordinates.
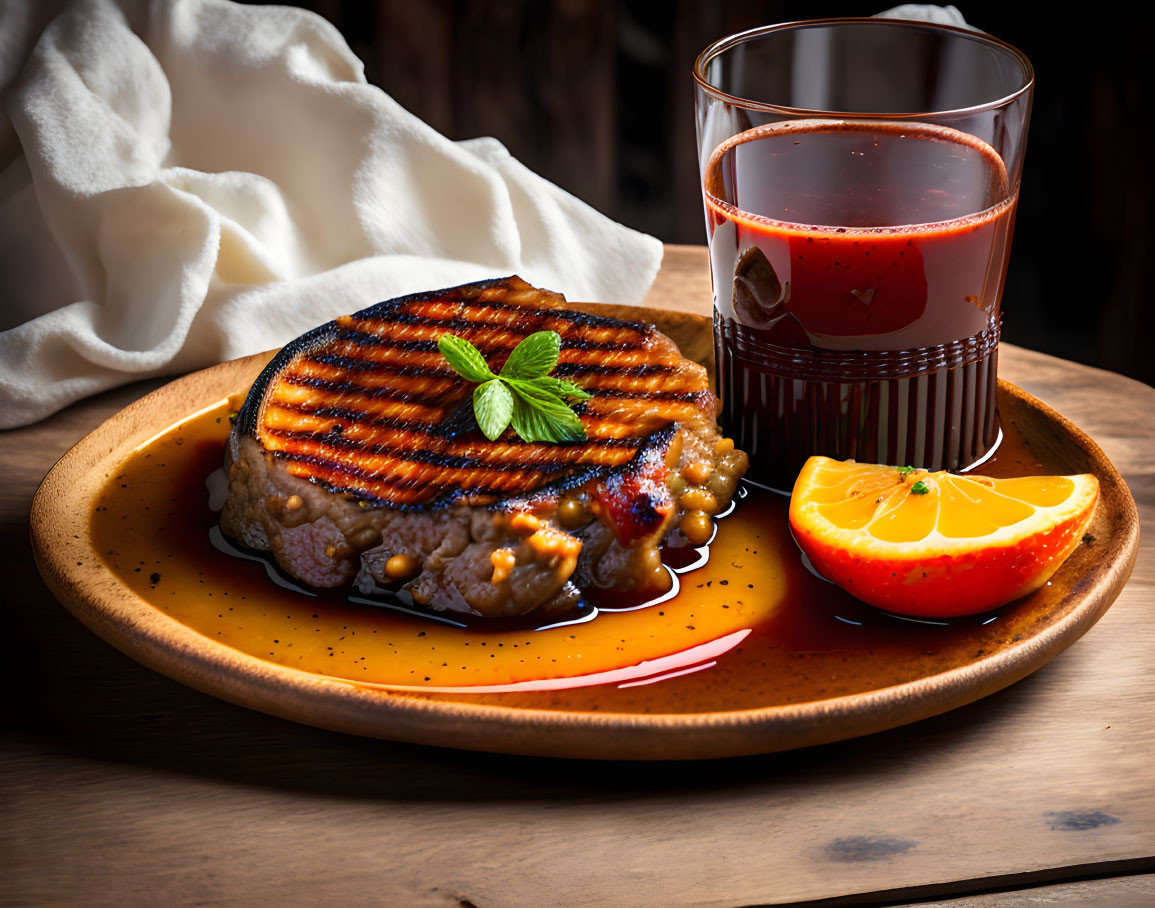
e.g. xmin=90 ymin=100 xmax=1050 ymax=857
xmin=714 ymin=313 xmax=999 ymax=491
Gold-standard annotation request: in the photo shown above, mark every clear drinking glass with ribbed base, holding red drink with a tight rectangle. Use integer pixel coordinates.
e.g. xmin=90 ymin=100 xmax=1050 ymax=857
xmin=693 ymin=18 xmax=1034 ymax=490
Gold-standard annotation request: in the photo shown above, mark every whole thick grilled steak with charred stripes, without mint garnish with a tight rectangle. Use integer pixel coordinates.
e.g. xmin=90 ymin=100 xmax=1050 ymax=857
xmin=221 ymin=277 xmax=746 ymax=616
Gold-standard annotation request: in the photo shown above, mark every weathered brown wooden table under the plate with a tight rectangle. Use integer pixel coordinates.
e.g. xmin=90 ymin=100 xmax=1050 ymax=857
xmin=0 ymin=246 xmax=1155 ymax=908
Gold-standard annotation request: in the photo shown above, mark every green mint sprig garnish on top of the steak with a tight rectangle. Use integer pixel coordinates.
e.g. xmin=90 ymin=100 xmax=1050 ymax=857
xmin=438 ymin=332 xmax=590 ymax=445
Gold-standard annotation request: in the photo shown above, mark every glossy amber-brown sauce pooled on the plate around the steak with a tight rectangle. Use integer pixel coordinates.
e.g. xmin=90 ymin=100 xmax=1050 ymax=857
xmin=90 ymin=401 xmax=1057 ymax=713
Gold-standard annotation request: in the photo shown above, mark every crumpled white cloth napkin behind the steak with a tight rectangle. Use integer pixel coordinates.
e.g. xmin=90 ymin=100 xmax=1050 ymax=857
xmin=0 ymin=0 xmax=662 ymax=427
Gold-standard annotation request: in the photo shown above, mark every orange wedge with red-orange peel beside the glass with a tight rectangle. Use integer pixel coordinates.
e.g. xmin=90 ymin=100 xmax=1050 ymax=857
xmin=790 ymin=457 xmax=1098 ymax=618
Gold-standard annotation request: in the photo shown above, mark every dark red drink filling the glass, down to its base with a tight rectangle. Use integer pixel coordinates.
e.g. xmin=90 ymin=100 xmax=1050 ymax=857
xmin=706 ymin=120 xmax=1016 ymax=490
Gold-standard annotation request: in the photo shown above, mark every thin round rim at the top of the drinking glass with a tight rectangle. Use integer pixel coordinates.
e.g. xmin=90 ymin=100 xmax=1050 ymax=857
xmin=692 ymin=16 xmax=1035 ymax=120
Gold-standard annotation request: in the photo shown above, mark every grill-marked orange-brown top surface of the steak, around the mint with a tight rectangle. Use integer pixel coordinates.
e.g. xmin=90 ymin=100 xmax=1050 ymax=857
xmin=241 ymin=278 xmax=716 ymax=507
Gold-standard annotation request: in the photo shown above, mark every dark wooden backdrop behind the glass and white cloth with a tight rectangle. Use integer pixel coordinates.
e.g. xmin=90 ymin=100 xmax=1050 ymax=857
xmin=272 ymin=0 xmax=1155 ymax=384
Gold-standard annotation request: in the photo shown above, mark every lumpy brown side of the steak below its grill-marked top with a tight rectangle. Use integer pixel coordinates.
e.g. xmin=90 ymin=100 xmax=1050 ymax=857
xmin=221 ymin=422 xmax=746 ymax=617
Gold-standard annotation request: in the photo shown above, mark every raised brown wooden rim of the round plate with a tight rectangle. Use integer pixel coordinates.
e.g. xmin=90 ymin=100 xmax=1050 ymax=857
xmin=30 ymin=332 xmax=1139 ymax=760
